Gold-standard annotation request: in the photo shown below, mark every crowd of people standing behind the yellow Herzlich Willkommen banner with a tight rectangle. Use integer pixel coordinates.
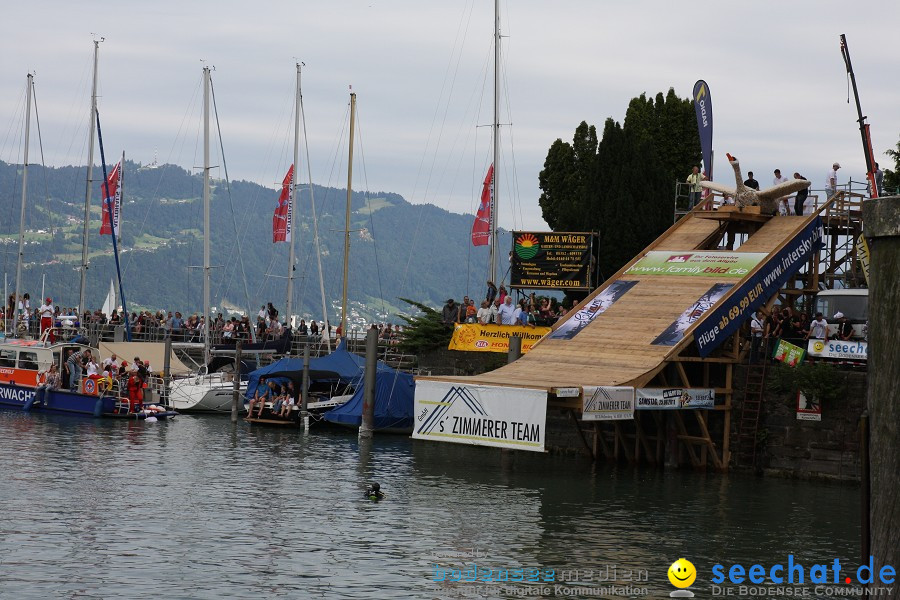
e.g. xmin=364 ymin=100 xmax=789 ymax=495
xmin=441 ymin=281 xmax=566 ymax=329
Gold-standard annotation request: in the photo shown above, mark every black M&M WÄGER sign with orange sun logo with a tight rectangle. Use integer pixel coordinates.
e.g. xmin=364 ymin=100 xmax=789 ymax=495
xmin=510 ymin=231 xmax=594 ymax=290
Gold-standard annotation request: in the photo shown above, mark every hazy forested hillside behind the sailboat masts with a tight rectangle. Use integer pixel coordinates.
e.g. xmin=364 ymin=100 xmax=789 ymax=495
xmin=0 ymin=157 xmax=510 ymax=320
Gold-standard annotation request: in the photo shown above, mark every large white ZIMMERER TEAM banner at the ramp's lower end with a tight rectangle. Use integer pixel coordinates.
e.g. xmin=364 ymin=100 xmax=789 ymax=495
xmin=412 ymin=380 xmax=547 ymax=452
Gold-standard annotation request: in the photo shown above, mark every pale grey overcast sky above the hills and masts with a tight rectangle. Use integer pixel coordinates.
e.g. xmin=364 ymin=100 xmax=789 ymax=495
xmin=0 ymin=0 xmax=900 ymax=229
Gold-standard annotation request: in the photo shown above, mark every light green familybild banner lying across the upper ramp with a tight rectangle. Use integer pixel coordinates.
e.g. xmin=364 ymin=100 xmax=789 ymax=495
xmin=624 ymin=250 xmax=766 ymax=279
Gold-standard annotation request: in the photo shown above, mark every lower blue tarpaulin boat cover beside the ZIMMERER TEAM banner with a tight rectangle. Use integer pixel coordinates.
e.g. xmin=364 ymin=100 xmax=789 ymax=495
xmin=324 ymin=368 xmax=416 ymax=431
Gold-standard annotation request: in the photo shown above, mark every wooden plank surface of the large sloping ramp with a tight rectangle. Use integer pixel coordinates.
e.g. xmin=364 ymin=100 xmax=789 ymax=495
xmin=417 ymin=210 xmax=816 ymax=393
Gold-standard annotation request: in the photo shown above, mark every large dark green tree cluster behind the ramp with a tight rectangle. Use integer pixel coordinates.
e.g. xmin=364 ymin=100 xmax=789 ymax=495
xmin=539 ymin=89 xmax=700 ymax=276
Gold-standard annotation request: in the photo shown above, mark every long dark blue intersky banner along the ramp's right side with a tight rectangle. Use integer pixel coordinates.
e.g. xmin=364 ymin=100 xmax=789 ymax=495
xmin=694 ymin=217 xmax=823 ymax=358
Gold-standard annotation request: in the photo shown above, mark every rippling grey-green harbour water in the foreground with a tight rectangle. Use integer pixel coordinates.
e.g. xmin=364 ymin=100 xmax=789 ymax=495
xmin=0 ymin=410 xmax=859 ymax=599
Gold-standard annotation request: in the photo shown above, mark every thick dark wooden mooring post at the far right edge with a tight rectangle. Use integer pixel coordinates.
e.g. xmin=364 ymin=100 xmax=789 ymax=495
xmin=862 ymin=196 xmax=900 ymax=576
